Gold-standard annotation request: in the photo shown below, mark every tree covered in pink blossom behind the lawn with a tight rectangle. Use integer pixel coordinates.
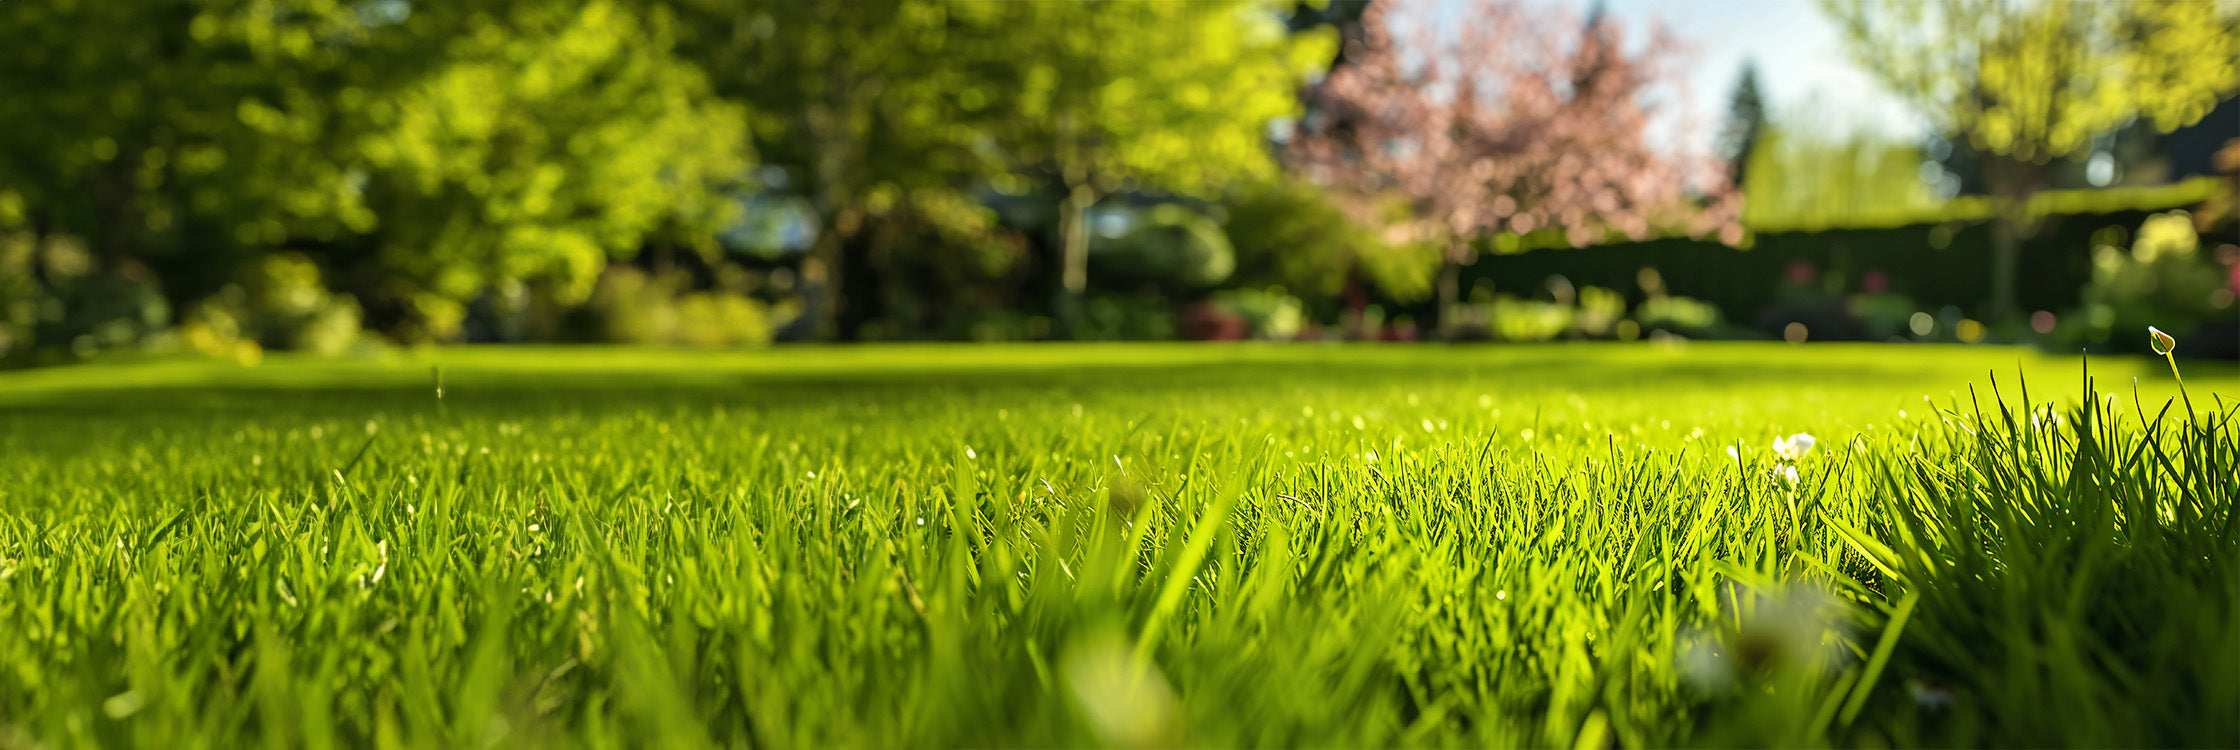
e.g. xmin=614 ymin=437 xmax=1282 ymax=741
xmin=1288 ymin=0 xmax=1740 ymax=335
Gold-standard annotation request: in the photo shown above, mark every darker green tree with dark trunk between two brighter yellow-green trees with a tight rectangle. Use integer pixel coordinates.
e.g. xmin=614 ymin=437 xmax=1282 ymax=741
xmin=647 ymin=0 xmax=1008 ymax=338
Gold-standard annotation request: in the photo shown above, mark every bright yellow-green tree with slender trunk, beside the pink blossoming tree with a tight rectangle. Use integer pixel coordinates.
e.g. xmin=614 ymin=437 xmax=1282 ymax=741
xmin=956 ymin=0 xmax=1331 ymax=331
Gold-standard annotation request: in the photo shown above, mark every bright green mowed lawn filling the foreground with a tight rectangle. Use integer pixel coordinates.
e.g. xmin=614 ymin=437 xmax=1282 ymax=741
xmin=0 ymin=345 xmax=2240 ymax=748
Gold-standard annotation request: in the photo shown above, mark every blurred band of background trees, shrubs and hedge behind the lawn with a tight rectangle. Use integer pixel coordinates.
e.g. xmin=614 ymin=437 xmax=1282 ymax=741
xmin=0 ymin=0 xmax=2240 ymax=365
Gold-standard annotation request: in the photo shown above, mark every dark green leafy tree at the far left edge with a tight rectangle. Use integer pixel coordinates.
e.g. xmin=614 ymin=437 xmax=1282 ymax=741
xmin=0 ymin=0 xmax=383 ymax=355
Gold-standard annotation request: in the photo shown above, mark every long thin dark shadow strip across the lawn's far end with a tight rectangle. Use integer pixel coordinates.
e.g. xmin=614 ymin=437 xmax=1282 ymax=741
xmin=0 ymin=358 xmax=1953 ymax=425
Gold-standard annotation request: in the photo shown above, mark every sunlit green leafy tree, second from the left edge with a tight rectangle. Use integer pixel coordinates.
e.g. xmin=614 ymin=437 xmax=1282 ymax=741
xmin=356 ymin=0 xmax=748 ymax=338
